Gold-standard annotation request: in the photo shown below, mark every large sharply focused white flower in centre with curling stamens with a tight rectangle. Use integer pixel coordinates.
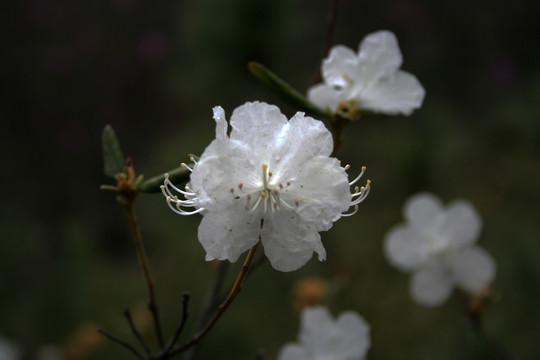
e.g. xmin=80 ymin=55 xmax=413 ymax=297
xmin=162 ymin=102 xmax=369 ymax=271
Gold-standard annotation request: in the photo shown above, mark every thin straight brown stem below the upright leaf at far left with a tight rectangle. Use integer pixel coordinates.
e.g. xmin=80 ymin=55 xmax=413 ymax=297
xmin=124 ymin=198 xmax=164 ymax=347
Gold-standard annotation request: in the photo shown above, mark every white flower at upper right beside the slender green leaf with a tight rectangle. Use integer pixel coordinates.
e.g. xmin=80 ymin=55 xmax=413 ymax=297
xmin=308 ymin=30 xmax=425 ymax=115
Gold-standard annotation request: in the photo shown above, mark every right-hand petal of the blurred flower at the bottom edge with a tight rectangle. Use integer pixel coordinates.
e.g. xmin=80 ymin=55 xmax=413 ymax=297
xmin=337 ymin=311 xmax=371 ymax=359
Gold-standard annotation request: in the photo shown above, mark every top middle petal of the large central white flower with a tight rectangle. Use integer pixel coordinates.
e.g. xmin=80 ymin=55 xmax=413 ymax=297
xmin=230 ymin=102 xmax=287 ymax=160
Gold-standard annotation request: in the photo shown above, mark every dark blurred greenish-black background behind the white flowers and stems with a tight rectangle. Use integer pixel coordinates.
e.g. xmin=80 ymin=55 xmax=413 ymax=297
xmin=0 ymin=0 xmax=540 ymax=360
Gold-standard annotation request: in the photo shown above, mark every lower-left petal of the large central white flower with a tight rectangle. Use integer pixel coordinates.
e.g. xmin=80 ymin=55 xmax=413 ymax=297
xmin=199 ymin=200 xmax=260 ymax=262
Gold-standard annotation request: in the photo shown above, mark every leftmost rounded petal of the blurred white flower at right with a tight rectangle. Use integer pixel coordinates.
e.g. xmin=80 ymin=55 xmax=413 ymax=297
xmin=384 ymin=225 xmax=430 ymax=271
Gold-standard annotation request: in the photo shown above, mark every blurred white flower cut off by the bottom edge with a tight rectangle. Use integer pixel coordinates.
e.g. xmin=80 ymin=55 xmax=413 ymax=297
xmin=278 ymin=306 xmax=371 ymax=360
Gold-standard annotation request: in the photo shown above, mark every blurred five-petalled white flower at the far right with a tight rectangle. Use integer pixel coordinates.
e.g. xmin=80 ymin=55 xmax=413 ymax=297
xmin=384 ymin=193 xmax=495 ymax=306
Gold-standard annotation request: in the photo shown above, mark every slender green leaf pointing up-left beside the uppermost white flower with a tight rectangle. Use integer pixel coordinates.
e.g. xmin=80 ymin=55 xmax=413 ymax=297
xmin=248 ymin=61 xmax=332 ymax=118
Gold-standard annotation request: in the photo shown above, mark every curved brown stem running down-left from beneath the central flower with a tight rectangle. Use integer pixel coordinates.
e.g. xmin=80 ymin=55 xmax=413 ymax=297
xmin=168 ymin=240 xmax=262 ymax=356
